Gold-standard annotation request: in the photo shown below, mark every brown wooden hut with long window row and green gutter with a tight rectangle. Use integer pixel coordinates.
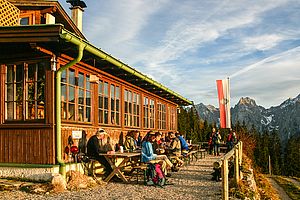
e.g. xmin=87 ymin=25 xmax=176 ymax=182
xmin=0 ymin=0 xmax=191 ymax=178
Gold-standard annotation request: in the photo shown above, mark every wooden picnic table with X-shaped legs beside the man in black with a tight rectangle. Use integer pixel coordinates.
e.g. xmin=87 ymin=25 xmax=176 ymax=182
xmin=99 ymin=152 xmax=141 ymax=183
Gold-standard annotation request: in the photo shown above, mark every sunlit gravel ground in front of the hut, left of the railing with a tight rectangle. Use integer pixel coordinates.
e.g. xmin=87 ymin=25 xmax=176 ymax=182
xmin=0 ymin=155 xmax=221 ymax=200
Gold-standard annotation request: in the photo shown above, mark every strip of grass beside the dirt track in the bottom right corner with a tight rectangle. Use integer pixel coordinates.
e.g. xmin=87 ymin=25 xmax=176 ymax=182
xmin=274 ymin=176 xmax=300 ymax=200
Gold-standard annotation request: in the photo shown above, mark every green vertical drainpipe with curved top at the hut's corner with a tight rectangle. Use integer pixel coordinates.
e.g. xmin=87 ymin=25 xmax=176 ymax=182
xmin=56 ymin=41 xmax=86 ymax=178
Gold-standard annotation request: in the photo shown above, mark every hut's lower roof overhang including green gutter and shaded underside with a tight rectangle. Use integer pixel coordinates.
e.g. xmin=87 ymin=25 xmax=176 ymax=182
xmin=0 ymin=24 xmax=192 ymax=106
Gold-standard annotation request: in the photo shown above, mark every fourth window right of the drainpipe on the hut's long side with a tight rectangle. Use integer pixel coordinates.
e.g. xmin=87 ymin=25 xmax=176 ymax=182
xmin=143 ymin=97 xmax=155 ymax=128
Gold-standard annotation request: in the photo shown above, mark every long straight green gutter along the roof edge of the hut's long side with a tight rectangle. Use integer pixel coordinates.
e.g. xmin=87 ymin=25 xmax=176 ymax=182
xmin=60 ymin=29 xmax=193 ymax=105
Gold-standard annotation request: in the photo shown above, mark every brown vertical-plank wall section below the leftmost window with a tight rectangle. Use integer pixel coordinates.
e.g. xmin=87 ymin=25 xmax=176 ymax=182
xmin=0 ymin=127 xmax=55 ymax=164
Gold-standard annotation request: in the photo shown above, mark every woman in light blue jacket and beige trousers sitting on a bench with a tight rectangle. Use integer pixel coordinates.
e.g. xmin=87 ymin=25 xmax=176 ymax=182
xmin=141 ymin=131 xmax=173 ymax=176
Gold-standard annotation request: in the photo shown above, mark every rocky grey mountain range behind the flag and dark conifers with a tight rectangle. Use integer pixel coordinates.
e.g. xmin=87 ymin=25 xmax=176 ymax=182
xmin=195 ymin=94 xmax=300 ymax=141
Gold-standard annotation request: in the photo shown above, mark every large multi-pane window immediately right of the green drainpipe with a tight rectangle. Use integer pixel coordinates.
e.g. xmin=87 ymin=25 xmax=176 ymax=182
xmin=61 ymin=69 xmax=91 ymax=122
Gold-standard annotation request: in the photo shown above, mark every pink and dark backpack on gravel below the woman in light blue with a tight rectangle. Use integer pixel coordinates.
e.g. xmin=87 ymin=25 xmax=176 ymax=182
xmin=146 ymin=163 xmax=166 ymax=187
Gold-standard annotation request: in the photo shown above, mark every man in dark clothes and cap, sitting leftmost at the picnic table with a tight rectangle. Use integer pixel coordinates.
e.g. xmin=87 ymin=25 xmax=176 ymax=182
xmin=87 ymin=128 xmax=113 ymax=177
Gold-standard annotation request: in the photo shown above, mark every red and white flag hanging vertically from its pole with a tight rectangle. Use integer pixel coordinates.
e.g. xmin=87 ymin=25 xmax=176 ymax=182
xmin=217 ymin=78 xmax=231 ymax=128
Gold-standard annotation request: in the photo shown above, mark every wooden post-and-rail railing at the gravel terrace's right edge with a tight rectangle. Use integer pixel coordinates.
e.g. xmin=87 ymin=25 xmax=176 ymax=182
xmin=221 ymin=141 xmax=243 ymax=200
